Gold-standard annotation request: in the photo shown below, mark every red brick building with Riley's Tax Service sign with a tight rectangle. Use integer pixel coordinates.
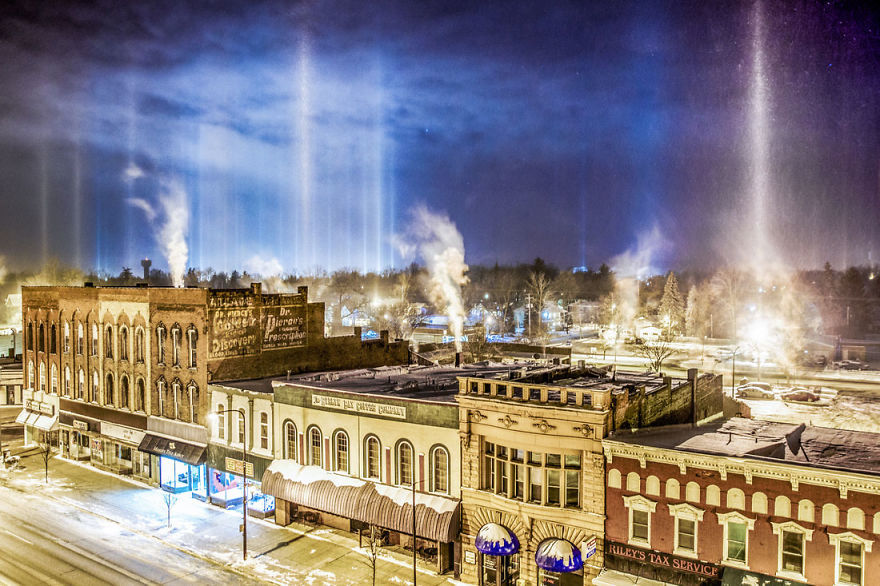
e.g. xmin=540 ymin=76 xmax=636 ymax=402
xmin=594 ymin=418 xmax=880 ymax=585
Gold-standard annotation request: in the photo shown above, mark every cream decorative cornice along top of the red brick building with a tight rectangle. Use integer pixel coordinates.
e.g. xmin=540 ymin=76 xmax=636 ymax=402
xmin=602 ymin=439 xmax=880 ymax=499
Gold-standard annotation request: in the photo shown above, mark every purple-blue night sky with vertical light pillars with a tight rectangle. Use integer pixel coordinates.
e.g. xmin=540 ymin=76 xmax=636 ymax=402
xmin=0 ymin=0 xmax=880 ymax=273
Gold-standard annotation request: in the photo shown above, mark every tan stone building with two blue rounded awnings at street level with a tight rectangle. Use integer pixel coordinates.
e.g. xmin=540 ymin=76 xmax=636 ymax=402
xmin=458 ymin=365 xmax=722 ymax=585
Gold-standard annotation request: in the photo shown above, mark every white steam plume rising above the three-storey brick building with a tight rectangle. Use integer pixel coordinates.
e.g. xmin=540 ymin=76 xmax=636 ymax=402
xmin=126 ymin=180 xmax=189 ymax=287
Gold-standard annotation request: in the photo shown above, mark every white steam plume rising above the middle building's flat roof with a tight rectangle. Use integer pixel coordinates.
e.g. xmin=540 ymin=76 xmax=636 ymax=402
xmin=394 ymin=205 xmax=468 ymax=352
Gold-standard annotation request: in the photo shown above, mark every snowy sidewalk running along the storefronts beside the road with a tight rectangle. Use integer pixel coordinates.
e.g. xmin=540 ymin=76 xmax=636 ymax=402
xmin=1 ymin=455 xmax=456 ymax=586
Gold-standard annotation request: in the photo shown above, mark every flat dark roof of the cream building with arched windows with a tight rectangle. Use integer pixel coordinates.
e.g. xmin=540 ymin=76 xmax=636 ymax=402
xmin=218 ymin=362 xmax=526 ymax=403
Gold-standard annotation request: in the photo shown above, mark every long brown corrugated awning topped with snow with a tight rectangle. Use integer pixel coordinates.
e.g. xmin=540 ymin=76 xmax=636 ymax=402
xmin=261 ymin=460 xmax=459 ymax=543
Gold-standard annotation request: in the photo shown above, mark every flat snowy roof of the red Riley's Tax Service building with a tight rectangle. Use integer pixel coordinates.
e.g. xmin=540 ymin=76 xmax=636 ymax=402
xmin=608 ymin=417 xmax=880 ymax=474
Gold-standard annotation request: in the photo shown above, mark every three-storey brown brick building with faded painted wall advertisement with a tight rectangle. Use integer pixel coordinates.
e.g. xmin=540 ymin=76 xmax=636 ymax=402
xmin=20 ymin=283 xmax=407 ymax=490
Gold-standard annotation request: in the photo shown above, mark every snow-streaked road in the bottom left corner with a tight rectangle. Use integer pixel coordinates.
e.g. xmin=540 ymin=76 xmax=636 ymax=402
xmin=0 ymin=472 xmax=241 ymax=585
